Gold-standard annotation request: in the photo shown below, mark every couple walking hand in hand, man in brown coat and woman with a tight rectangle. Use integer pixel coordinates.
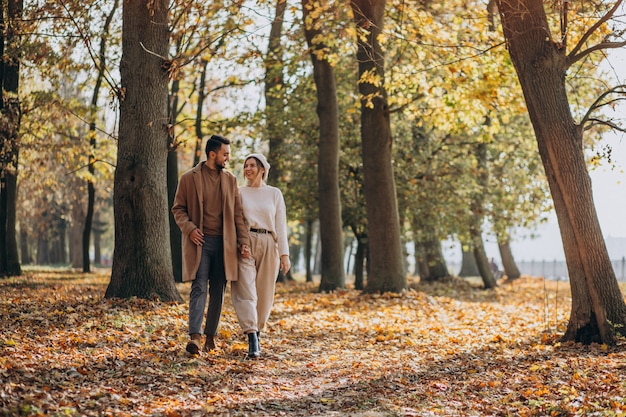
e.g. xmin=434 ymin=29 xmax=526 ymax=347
xmin=172 ymin=135 xmax=291 ymax=358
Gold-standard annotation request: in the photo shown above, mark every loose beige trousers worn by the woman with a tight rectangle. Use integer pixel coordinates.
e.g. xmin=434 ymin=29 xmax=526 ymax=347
xmin=230 ymin=232 xmax=280 ymax=333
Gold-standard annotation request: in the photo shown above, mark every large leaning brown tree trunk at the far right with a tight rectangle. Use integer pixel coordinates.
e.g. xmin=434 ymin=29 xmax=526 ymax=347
xmin=498 ymin=0 xmax=626 ymax=344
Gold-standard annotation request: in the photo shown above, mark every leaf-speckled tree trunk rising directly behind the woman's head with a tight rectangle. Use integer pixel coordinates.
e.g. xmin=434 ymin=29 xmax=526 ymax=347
xmin=265 ymin=0 xmax=287 ymax=187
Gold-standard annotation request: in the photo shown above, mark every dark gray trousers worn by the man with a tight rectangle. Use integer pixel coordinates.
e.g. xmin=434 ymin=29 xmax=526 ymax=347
xmin=189 ymin=236 xmax=226 ymax=336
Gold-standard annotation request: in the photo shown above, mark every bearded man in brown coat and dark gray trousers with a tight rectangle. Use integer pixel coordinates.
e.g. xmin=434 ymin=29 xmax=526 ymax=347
xmin=172 ymin=135 xmax=250 ymax=354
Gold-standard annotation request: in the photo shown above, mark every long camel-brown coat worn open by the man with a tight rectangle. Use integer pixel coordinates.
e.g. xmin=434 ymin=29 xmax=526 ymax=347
xmin=172 ymin=161 xmax=250 ymax=282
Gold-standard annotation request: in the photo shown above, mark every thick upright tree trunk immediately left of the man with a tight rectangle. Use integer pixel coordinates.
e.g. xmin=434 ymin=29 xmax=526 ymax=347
xmin=105 ymin=0 xmax=182 ymax=301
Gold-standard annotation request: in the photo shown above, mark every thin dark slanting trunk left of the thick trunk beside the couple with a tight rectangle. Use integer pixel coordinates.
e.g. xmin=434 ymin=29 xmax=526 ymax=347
xmin=82 ymin=0 xmax=119 ymax=272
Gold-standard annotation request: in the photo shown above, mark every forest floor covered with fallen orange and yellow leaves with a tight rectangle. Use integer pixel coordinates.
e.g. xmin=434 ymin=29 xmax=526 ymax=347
xmin=0 ymin=271 xmax=626 ymax=417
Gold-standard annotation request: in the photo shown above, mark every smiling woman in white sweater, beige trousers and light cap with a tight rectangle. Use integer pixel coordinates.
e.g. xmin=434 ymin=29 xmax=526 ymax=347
xmin=231 ymin=153 xmax=291 ymax=358
